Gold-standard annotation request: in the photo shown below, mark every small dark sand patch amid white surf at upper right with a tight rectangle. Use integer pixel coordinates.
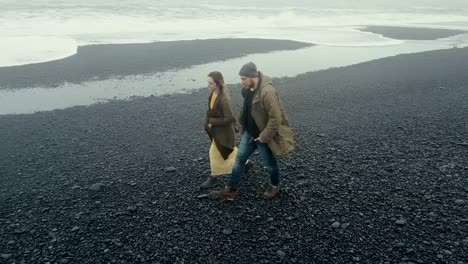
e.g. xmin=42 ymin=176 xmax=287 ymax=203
xmin=361 ymin=26 xmax=468 ymax=40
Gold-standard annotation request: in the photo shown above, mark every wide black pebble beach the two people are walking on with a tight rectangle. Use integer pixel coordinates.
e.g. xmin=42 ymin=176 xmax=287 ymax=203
xmin=0 ymin=46 xmax=468 ymax=264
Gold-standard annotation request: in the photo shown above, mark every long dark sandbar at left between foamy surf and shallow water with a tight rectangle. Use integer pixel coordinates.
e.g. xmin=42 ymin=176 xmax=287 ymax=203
xmin=0 ymin=39 xmax=311 ymax=89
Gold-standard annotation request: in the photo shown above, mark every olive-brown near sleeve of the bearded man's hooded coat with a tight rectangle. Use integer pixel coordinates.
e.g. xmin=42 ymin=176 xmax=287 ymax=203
xmin=260 ymin=89 xmax=281 ymax=143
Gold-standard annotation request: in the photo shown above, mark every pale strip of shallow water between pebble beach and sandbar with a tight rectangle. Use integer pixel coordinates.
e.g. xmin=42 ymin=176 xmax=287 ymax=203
xmin=0 ymin=37 xmax=468 ymax=115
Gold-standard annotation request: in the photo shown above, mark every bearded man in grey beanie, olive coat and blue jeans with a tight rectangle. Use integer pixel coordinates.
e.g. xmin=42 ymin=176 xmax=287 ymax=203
xmin=212 ymin=62 xmax=293 ymax=201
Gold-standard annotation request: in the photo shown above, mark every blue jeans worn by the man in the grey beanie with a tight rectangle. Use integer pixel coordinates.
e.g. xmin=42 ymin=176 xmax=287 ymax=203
xmin=228 ymin=131 xmax=280 ymax=189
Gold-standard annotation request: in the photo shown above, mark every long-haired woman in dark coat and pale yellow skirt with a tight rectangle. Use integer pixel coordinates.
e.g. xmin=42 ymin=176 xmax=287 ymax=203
xmin=202 ymin=71 xmax=237 ymax=188
